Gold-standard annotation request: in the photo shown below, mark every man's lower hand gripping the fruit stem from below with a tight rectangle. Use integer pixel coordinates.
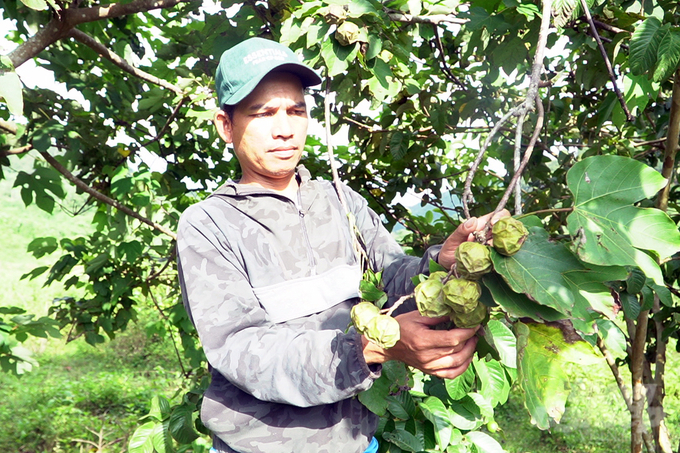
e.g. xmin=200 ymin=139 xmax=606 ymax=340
xmin=362 ymin=311 xmax=477 ymax=379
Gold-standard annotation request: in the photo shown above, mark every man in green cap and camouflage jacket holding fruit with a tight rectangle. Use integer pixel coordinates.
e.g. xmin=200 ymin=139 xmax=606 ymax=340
xmin=178 ymin=38 xmax=508 ymax=453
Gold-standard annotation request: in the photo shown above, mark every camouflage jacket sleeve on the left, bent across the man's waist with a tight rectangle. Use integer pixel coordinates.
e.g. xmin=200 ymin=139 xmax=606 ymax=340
xmin=177 ymin=205 xmax=380 ymax=407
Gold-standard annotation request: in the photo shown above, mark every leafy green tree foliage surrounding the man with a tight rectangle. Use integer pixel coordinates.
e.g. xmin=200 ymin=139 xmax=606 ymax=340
xmin=0 ymin=0 xmax=680 ymax=452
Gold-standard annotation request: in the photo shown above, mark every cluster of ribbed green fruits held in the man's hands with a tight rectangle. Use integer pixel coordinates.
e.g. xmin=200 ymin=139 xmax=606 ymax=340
xmin=351 ymin=217 xmax=529 ymax=348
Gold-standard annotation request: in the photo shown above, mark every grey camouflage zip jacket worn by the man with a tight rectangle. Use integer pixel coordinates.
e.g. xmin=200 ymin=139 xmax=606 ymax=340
xmin=177 ymin=167 xmax=437 ymax=453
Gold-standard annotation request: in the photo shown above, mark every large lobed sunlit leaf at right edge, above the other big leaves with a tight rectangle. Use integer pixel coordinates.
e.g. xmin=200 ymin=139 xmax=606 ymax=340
xmin=567 ymin=156 xmax=680 ymax=284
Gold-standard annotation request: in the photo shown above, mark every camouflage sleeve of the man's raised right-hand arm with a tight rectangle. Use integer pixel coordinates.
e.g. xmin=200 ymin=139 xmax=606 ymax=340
xmin=345 ymin=186 xmax=441 ymax=310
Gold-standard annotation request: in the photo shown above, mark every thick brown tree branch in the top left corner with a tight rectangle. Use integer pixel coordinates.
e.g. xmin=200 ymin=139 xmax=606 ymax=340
xmin=8 ymin=0 xmax=196 ymax=68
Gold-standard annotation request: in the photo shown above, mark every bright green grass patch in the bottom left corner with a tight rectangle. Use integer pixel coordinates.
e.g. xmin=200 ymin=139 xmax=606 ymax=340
xmin=0 ymin=326 xmax=181 ymax=453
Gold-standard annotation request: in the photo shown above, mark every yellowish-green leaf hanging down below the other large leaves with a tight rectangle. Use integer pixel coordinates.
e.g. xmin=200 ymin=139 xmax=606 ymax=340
xmin=515 ymin=322 xmax=600 ymax=429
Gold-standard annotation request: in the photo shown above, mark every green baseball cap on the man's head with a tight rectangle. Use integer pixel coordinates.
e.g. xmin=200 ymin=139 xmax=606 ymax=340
xmin=215 ymin=38 xmax=321 ymax=107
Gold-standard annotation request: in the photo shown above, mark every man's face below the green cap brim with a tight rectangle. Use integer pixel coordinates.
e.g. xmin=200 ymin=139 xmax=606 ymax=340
xmin=215 ymin=72 xmax=309 ymax=190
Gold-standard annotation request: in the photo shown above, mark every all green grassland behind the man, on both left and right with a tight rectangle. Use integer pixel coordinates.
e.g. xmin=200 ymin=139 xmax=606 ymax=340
xmin=0 ymin=156 xmax=680 ymax=453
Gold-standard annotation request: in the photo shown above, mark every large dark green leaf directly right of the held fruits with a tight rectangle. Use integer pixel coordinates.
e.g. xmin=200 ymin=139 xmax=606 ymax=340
xmin=491 ymin=227 xmax=626 ymax=320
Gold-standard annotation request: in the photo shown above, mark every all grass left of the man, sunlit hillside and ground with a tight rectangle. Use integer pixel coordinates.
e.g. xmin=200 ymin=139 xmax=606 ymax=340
xmin=0 ymin=155 xmax=191 ymax=453
